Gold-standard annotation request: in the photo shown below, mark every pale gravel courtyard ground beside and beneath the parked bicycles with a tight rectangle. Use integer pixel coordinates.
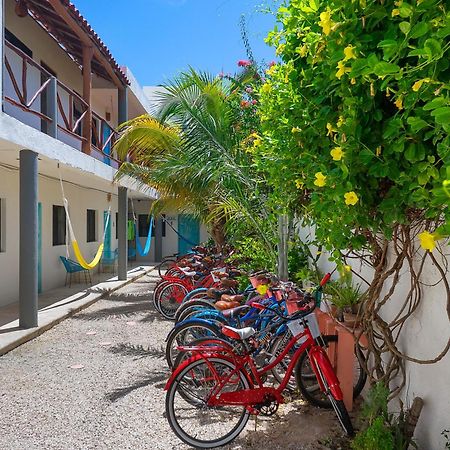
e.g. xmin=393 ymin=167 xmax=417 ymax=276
xmin=0 ymin=273 xmax=352 ymax=450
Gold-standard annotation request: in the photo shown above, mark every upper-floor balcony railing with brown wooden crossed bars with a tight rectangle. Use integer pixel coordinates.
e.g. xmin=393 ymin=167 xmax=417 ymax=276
xmin=3 ymin=41 xmax=120 ymax=168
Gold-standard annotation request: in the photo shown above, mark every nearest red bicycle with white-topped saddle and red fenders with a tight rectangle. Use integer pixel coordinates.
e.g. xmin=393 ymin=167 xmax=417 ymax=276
xmin=165 ymin=274 xmax=353 ymax=448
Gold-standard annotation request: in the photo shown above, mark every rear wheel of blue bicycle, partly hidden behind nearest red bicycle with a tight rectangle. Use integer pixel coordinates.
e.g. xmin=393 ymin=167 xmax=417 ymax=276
xmin=166 ymin=320 xmax=223 ymax=368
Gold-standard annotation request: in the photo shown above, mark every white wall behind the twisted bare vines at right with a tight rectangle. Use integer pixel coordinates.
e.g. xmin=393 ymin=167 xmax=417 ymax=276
xmin=300 ymin=225 xmax=450 ymax=450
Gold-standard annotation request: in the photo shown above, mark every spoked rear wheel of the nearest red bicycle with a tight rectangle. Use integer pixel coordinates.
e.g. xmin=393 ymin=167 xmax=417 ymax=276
xmin=166 ymin=358 xmax=250 ymax=448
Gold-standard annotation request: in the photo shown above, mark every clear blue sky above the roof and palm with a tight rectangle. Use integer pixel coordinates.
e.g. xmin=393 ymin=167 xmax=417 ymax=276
xmin=73 ymin=0 xmax=278 ymax=85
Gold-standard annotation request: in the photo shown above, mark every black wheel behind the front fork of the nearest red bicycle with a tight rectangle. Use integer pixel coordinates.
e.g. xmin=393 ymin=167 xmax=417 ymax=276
xmin=295 ymin=335 xmax=367 ymax=409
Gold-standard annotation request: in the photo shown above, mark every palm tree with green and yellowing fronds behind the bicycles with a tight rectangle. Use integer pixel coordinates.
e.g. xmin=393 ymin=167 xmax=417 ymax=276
xmin=116 ymin=69 xmax=275 ymax=258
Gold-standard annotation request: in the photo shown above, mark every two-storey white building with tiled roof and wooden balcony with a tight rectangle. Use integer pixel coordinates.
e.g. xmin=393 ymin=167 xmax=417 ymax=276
xmin=0 ymin=0 xmax=207 ymax=326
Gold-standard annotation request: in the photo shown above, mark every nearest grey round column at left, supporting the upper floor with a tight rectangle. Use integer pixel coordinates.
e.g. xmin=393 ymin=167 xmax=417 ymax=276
xmin=19 ymin=150 xmax=38 ymax=328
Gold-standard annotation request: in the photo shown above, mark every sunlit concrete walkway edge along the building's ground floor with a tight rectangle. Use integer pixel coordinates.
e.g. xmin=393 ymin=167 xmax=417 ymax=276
xmin=0 ymin=266 xmax=154 ymax=356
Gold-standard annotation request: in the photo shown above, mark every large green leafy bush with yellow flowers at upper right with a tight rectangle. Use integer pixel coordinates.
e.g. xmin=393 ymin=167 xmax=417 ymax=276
xmin=254 ymin=0 xmax=450 ymax=251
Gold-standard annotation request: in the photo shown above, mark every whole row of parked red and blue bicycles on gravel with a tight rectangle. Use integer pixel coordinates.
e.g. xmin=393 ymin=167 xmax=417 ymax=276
xmin=153 ymin=247 xmax=366 ymax=448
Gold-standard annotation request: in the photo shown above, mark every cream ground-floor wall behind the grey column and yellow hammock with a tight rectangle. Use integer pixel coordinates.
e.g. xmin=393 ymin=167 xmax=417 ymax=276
xmin=0 ymin=167 xmax=117 ymax=306
